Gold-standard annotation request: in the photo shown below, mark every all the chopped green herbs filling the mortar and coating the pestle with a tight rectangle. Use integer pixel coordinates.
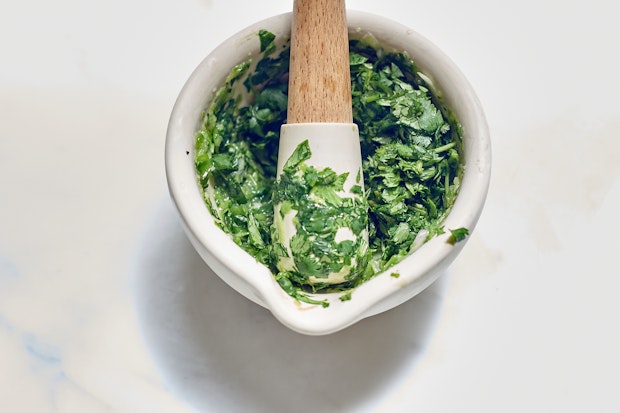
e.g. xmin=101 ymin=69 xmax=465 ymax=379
xmin=195 ymin=30 xmax=467 ymax=306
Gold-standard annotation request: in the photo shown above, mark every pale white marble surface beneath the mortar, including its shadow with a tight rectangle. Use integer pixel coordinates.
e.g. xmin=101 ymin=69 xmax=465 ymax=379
xmin=0 ymin=0 xmax=620 ymax=413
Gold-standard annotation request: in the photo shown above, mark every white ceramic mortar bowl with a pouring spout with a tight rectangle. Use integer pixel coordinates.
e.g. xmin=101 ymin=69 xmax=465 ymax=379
xmin=165 ymin=10 xmax=491 ymax=335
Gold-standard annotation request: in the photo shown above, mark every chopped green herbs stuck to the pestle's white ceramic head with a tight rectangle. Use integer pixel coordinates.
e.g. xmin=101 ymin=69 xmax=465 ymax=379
xmin=273 ymin=140 xmax=369 ymax=288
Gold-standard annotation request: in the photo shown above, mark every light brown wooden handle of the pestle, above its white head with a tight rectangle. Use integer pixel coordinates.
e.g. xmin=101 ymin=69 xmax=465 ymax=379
xmin=287 ymin=0 xmax=353 ymax=123
